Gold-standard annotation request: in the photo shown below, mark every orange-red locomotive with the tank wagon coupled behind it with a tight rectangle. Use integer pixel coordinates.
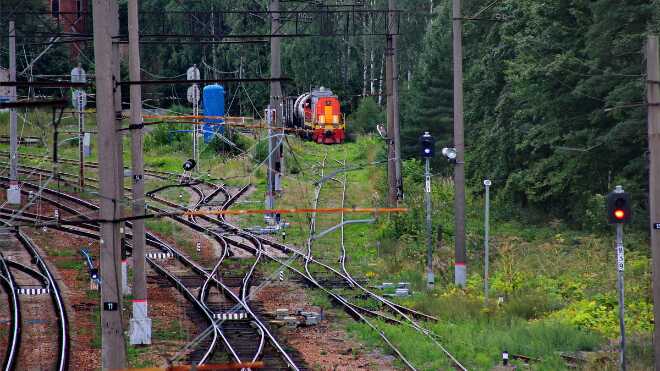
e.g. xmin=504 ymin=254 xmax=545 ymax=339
xmin=284 ymin=87 xmax=346 ymax=144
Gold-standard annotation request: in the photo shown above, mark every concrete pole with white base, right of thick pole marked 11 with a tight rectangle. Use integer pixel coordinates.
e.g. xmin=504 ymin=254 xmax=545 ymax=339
xmin=128 ymin=0 xmax=151 ymax=344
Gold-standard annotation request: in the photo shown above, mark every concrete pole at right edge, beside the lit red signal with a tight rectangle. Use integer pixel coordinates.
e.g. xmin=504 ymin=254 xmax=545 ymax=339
xmin=646 ymin=36 xmax=660 ymax=371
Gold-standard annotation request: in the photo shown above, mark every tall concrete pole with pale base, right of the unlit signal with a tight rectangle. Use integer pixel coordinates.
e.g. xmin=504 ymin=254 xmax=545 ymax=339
xmin=452 ymin=0 xmax=467 ymax=287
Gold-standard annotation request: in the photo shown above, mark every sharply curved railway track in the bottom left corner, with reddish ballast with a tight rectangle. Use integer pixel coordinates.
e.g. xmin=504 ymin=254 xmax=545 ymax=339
xmin=0 ymin=222 xmax=70 ymax=371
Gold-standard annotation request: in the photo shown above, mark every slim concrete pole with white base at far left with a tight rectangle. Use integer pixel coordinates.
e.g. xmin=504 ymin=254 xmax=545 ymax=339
xmin=7 ymin=21 xmax=21 ymax=205
